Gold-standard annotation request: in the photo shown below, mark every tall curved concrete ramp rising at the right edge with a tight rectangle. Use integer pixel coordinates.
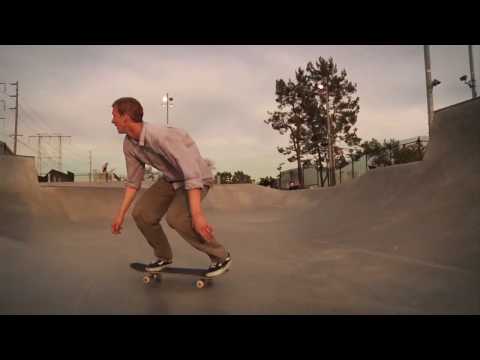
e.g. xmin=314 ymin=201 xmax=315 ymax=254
xmin=301 ymin=99 xmax=480 ymax=270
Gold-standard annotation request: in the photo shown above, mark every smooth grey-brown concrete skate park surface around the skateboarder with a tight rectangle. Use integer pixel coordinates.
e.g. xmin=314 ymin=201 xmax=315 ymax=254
xmin=0 ymin=99 xmax=480 ymax=315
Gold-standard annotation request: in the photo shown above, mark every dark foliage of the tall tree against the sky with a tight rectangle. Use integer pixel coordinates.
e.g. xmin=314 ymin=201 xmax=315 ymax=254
xmin=265 ymin=57 xmax=361 ymax=187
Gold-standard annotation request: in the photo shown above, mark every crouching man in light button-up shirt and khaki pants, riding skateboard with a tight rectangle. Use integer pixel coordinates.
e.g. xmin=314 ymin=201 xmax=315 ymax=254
xmin=112 ymin=97 xmax=231 ymax=277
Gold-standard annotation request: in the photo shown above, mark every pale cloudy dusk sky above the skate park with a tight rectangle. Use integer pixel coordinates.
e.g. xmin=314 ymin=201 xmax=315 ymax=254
xmin=0 ymin=45 xmax=480 ymax=180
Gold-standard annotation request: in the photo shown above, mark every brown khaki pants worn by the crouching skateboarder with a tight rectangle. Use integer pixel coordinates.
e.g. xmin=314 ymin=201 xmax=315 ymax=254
xmin=132 ymin=178 xmax=228 ymax=261
